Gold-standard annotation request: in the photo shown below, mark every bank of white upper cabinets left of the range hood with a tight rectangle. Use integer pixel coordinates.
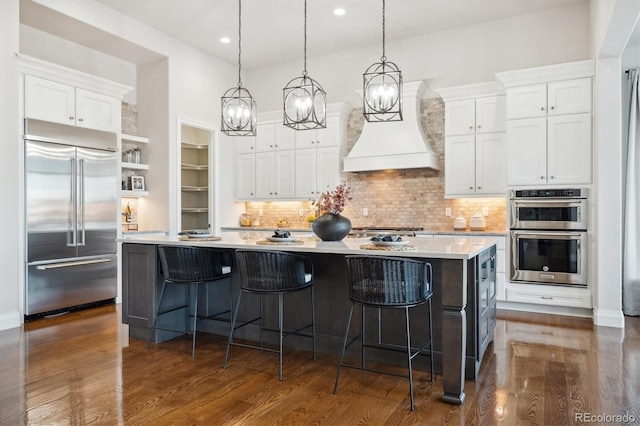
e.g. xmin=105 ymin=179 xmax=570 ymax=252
xmin=235 ymin=104 xmax=348 ymax=200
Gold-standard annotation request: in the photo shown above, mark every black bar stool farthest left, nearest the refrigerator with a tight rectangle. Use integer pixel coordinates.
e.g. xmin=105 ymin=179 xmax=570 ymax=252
xmin=147 ymin=246 xmax=233 ymax=358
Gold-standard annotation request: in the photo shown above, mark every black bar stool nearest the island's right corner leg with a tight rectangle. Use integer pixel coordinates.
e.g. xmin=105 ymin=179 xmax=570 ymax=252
xmin=333 ymin=256 xmax=433 ymax=411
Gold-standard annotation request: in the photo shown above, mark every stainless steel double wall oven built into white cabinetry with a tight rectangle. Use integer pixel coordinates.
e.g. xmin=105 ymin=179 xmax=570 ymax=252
xmin=509 ymin=188 xmax=588 ymax=287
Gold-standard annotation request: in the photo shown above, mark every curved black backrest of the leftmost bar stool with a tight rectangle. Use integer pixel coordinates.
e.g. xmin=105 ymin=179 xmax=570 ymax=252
xmin=158 ymin=246 xmax=231 ymax=283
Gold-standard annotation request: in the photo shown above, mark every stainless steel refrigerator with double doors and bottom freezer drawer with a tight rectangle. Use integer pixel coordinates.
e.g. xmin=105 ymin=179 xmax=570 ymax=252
xmin=25 ymin=128 xmax=119 ymax=317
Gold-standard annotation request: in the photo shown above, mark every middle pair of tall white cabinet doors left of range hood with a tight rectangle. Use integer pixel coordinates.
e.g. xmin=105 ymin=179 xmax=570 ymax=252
xmin=255 ymin=150 xmax=295 ymax=199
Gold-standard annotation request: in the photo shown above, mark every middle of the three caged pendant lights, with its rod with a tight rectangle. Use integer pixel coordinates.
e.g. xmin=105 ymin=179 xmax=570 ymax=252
xmin=282 ymin=0 xmax=327 ymax=130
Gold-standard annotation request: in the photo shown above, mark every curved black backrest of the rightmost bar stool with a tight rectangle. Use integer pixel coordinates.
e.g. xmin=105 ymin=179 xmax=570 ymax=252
xmin=345 ymin=256 xmax=432 ymax=307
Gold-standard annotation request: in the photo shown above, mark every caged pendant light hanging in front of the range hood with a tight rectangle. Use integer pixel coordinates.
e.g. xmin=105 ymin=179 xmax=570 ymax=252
xmin=362 ymin=0 xmax=402 ymax=122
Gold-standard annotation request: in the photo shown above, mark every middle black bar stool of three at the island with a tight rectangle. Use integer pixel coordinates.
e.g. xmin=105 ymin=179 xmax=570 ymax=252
xmin=224 ymin=250 xmax=316 ymax=380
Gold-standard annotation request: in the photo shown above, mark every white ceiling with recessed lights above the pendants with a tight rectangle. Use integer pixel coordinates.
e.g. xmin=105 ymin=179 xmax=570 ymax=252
xmin=90 ymin=0 xmax=588 ymax=69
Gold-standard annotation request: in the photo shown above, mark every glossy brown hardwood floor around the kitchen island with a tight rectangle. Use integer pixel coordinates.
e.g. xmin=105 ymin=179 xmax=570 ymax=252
xmin=0 ymin=305 xmax=640 ymax=425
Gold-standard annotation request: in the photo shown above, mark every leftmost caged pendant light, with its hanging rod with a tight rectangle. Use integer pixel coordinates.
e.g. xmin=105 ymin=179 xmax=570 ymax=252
xmin=221 ymin=0 xmax=258 ymax=136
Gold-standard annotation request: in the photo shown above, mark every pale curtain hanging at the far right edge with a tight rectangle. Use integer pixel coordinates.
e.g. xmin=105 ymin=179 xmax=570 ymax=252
xmin=622 ymin=68 xmax=640 ymax=315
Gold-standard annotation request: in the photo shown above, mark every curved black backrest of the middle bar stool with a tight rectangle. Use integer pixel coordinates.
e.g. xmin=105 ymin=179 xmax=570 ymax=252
xmin=236 ymin=250 xmax=313 ymax=292
